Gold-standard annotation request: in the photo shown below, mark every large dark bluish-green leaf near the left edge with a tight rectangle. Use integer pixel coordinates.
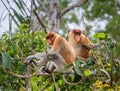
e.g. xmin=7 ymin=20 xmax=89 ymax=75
xmin=2 ymin=52 xmax=12 ymax=70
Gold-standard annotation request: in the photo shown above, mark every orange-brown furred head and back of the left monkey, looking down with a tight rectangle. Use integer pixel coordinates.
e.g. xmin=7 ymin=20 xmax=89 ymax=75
xmin=46 ymin=32 xmax=75 ymax=63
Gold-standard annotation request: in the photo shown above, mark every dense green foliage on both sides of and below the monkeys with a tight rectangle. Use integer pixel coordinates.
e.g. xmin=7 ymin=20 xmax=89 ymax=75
xmin=0 ymin=24 xmax=120 ymax=91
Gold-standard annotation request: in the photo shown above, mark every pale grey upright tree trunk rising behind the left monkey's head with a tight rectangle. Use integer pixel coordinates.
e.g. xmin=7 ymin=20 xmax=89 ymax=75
xmin=47 ymin=0 xmax=59 ymax=32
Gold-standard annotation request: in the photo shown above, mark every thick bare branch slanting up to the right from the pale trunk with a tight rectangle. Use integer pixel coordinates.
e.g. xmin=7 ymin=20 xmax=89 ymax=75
xmin=57 ymin=0 xmax=88 ymax=19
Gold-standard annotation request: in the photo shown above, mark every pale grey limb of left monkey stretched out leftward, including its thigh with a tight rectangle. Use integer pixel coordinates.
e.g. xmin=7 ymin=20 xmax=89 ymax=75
xmin=25 ymin=51 xmax=66 ymax=68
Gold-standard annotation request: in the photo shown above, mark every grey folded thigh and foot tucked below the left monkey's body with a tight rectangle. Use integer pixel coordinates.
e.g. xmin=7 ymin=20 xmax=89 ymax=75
xmin=35 ymin=52 xmax=66 ymax=75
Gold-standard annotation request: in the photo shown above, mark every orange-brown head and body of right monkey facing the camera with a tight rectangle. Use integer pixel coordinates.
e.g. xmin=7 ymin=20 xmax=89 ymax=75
xmin=68 ymin=29 xmax=94 ymax=60
